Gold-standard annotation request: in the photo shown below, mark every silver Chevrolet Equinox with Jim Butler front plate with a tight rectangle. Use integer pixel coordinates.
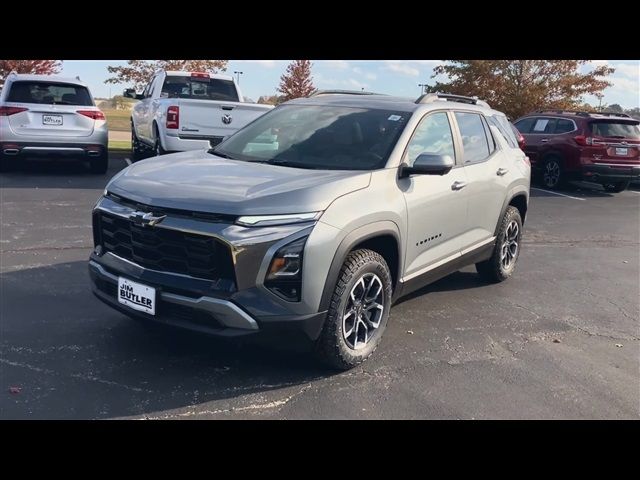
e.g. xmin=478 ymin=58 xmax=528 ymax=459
xmin=89 ymin=91 xmax=531 ymax=369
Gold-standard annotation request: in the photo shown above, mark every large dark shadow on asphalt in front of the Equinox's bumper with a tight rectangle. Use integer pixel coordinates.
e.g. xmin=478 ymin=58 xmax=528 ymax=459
xmin=0 ymin=261 xmax=336 ymax=418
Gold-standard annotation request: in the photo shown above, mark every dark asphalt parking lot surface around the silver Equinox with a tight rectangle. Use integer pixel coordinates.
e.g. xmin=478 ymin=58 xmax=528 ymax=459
xmin=0 ymin=158 xmax=640 ymax=419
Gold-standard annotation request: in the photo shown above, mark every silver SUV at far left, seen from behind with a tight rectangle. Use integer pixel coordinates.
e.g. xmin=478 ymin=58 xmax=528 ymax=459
xmin=0 ymin=72 xmax=109 ymax=174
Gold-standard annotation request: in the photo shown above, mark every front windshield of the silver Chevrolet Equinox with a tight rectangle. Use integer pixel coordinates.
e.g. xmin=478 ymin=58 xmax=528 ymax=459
xmin=211 ymin=105 xmax=411 ymax=170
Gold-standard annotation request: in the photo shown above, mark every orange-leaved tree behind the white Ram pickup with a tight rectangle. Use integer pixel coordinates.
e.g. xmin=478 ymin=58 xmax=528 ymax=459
xmin=104 ymin=60 xmax=228 ymax=90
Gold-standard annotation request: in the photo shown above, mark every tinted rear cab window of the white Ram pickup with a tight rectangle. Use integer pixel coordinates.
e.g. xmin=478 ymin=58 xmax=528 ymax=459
xmin=162 ymin=76 xmax=239 ymax=102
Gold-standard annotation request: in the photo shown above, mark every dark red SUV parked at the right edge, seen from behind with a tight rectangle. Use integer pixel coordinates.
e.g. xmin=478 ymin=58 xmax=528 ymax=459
xmin=514 ymin=110 xmax=640 ymax=192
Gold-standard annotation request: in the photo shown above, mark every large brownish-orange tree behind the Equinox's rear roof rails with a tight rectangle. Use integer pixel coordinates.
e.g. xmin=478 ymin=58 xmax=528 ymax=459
xmin=428 ymin=60 xmax=615 ymax=118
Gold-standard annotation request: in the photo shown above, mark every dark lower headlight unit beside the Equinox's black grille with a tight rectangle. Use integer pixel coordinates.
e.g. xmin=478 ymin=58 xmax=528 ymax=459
xmin=264 ymin=237 xmax=307 ymax=302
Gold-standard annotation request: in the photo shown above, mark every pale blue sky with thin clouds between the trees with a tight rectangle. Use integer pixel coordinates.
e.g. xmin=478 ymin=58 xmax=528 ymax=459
xmin=62 ymin=60 xmax=640 ymax=108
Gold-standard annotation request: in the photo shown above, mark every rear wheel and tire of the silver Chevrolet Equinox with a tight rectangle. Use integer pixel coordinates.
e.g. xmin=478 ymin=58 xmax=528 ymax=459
xmin=476 ymin=206 xmax=522 ymax=282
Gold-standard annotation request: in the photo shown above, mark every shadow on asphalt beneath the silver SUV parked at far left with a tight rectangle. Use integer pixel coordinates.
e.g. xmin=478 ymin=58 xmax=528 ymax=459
xmin=0 ymin=154 xmax=127 ymax=189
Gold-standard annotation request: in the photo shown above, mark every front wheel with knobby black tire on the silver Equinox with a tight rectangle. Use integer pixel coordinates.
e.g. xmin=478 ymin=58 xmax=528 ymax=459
xmin=315 ymin=249 xmax=393 ymax=370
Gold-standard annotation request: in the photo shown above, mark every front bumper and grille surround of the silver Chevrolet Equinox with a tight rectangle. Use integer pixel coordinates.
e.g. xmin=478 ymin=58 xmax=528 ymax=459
xmin=89 ymin=197 xmax=326 ymax=339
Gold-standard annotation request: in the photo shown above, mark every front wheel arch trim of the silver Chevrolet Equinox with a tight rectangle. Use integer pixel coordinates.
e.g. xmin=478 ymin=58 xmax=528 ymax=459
xmin=318 ymin=220 xmax=403 ymax=312
